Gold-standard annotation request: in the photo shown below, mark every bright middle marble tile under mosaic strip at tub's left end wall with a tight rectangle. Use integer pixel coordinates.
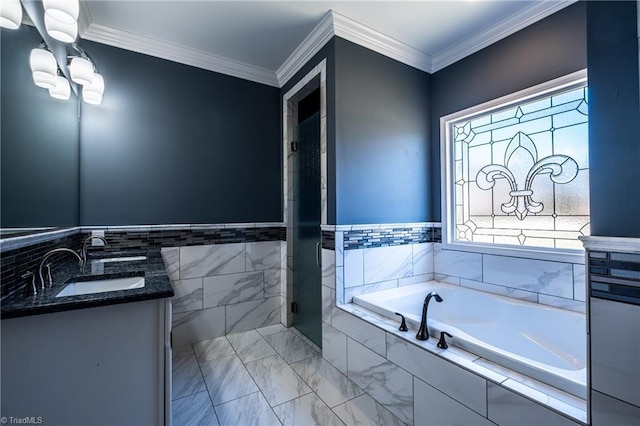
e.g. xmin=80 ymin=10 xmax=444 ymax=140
xmin=358 ymin=244 xmax=413 ymax=284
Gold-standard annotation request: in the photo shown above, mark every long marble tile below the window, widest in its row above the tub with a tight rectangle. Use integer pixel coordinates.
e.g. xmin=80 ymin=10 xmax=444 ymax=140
xmin=482 ymin=254 xmax=573 ymax=299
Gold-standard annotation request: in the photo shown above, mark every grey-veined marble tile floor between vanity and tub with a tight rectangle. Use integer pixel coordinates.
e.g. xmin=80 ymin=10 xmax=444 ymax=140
xmin=172 ymin=324 xmax=403 ymax=426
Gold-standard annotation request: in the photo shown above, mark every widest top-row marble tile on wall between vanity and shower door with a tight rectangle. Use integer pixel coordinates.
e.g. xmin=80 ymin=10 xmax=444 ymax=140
xmin=180 ymin=243 xmax=246 ymax=279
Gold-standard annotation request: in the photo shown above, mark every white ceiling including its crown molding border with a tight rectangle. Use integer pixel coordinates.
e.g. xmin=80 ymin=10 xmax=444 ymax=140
xmin=80 ymin=0 xmax=575 ymax=87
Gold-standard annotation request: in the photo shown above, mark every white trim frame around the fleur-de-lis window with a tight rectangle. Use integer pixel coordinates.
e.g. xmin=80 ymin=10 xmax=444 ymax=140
xmin=440 ymin=69 xmax=587 ymax=264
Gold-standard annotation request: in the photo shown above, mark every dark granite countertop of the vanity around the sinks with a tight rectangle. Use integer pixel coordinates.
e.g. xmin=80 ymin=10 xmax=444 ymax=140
xmin=0 ymin=249 xmax=174 ymax=319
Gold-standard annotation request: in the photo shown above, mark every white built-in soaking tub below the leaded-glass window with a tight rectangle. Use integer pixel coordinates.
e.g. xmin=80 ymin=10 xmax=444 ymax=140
xmin=353 ymin=281 xmax=587 ymax=399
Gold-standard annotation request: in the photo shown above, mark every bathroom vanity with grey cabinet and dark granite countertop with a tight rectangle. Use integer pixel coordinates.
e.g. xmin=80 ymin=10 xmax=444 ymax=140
xmin=0 ymin=251 xmax=173 ymax=425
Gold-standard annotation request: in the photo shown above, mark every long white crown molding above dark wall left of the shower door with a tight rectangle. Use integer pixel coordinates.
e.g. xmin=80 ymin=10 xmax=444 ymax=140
xmin=82 ymin=23 xmax=280 ymax=87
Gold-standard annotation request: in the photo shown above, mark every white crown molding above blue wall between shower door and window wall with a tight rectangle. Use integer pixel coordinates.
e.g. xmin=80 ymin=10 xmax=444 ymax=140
xmin=331 ymin=11 xmax=433 ymax=72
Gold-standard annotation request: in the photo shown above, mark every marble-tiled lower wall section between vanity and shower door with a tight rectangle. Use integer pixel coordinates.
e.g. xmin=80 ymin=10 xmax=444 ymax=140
xmin=162 ymin=241 xmax=285 ymax=345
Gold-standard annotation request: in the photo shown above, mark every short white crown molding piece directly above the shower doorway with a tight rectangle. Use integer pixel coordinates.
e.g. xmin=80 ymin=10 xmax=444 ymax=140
xmin=276 ymin=12 xmax=334 ymax=87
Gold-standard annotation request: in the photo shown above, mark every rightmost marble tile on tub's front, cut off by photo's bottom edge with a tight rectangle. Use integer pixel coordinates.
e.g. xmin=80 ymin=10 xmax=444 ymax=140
xmin=487 ymin=382 xmax=578 ymax=426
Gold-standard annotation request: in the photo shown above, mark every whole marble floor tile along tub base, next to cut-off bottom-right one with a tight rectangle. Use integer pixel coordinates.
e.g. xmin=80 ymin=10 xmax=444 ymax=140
xmin=291 ymin=356 xmax=364 ymax=407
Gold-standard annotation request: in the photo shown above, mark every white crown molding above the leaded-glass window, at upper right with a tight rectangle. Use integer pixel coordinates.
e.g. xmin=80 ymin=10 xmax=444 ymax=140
xmin=429 ymin=0 xmax=578 ymax=73
